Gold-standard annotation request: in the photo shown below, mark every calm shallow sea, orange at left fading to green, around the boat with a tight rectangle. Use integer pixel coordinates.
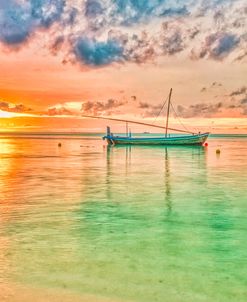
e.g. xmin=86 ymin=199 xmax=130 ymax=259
xmin=0 ymin=134 xmax=247 ymax=302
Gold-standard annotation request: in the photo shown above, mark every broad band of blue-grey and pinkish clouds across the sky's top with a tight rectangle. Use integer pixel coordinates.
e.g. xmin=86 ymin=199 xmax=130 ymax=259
xmin=0 ymin=0 xmax=247 ymax=68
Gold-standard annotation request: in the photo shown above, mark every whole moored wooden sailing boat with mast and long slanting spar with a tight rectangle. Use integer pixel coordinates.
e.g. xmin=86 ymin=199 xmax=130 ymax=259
xmin=83 ymin=88 xmax=209 ymax=146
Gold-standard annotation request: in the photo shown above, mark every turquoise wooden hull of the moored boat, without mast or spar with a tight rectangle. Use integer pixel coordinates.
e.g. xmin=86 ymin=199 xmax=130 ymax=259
xmin=103 ymin=132 xmax=209 ymax=146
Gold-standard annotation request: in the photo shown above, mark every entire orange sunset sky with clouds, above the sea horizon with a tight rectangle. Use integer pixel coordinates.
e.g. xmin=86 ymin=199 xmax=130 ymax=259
xmin=0 ymin=0 xmax=247 ymax=133
